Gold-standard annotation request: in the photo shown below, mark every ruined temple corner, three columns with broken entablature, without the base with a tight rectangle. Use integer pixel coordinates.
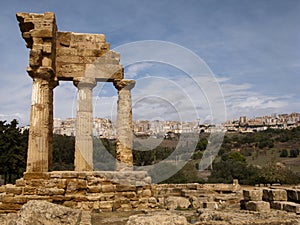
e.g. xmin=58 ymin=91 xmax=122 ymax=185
xmin=17 ymin=12 xmax=135 ymax=173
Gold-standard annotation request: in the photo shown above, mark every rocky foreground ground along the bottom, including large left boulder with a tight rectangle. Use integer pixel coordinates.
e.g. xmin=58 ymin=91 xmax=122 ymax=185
xmin=0 ymin=200 xmax=300 ymax=225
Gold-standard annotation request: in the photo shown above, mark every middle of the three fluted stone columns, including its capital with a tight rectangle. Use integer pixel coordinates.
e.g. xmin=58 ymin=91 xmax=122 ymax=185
xmin=74 ymin=77 xmax=96 ymax=171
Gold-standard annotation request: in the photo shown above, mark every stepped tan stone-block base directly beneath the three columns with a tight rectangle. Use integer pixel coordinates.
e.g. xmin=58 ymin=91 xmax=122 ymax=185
xmin=0 ymin=171 xmax=152 ymax=213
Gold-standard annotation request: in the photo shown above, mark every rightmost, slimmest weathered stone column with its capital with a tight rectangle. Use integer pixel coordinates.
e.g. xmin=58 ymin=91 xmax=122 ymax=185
xmin=114 ymin=80 xmax=135 ymax=171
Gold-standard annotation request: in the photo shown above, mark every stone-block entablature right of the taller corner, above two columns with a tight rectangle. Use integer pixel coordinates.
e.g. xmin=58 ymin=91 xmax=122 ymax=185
xmin=56 ymin=32 xmax=123 ymax=81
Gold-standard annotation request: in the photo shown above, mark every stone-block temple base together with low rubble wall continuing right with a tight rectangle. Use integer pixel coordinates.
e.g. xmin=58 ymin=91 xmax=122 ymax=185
xmin=0 ymin=177 xmax=246 ymax=214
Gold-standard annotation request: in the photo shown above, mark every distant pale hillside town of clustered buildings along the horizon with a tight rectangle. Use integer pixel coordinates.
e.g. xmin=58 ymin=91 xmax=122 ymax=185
xmin=53 ymin=113 xmax=300 ymax=139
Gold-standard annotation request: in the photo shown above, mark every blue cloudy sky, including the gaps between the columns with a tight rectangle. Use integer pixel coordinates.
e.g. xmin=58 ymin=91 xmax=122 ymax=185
xmin=0 ymin=0 xmax=300 ymax=124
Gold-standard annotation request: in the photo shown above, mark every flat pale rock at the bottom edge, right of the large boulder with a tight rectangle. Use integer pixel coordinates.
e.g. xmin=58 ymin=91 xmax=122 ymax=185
xmin=127 ymin=212 xmax=188 ymax=225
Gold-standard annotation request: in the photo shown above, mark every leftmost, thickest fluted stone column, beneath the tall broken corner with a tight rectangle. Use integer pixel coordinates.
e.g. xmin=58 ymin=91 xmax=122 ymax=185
xmin=26 ymin=73 xmax=57 ymax=172
